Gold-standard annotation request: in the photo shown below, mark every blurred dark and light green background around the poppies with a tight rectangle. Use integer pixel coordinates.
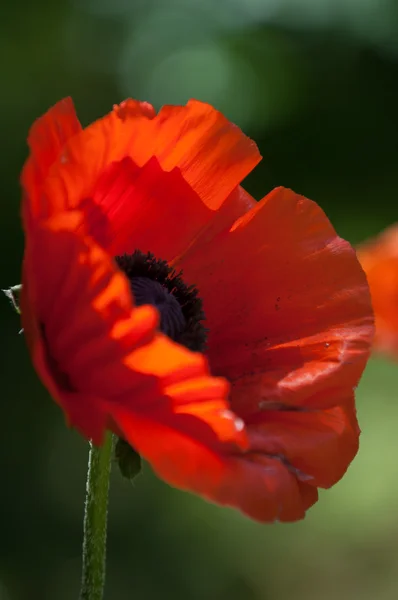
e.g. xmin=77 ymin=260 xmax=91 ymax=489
xmin=0 ymin=0 xmax=398 ymax=600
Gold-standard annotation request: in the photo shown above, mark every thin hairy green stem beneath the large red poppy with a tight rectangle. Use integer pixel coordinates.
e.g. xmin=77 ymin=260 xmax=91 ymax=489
xmin=80 ymin=432 xmax=113 ymax=600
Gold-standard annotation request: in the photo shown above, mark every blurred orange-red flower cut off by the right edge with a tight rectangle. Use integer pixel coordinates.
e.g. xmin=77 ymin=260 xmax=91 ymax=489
xmin=358 ymin=225 xmax=398 ymax=358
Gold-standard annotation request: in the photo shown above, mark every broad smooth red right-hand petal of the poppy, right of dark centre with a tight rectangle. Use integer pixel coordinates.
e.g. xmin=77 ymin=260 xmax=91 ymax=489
xmin=179 ymin=188 xmax=373 ymax=418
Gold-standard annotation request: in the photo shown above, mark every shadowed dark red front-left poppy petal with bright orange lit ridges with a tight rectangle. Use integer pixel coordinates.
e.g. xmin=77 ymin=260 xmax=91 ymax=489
xmin=23 ymin=211 xmax=246 ymax=454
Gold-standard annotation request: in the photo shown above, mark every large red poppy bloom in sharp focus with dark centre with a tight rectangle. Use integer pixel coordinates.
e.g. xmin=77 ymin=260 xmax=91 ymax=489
xmin=22 ymin=99 xmax=373 ymax=521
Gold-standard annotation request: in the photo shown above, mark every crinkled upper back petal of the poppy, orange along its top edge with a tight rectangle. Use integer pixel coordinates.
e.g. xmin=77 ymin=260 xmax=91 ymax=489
xmin=22 ymin=99 xmax=260 ymax=261
